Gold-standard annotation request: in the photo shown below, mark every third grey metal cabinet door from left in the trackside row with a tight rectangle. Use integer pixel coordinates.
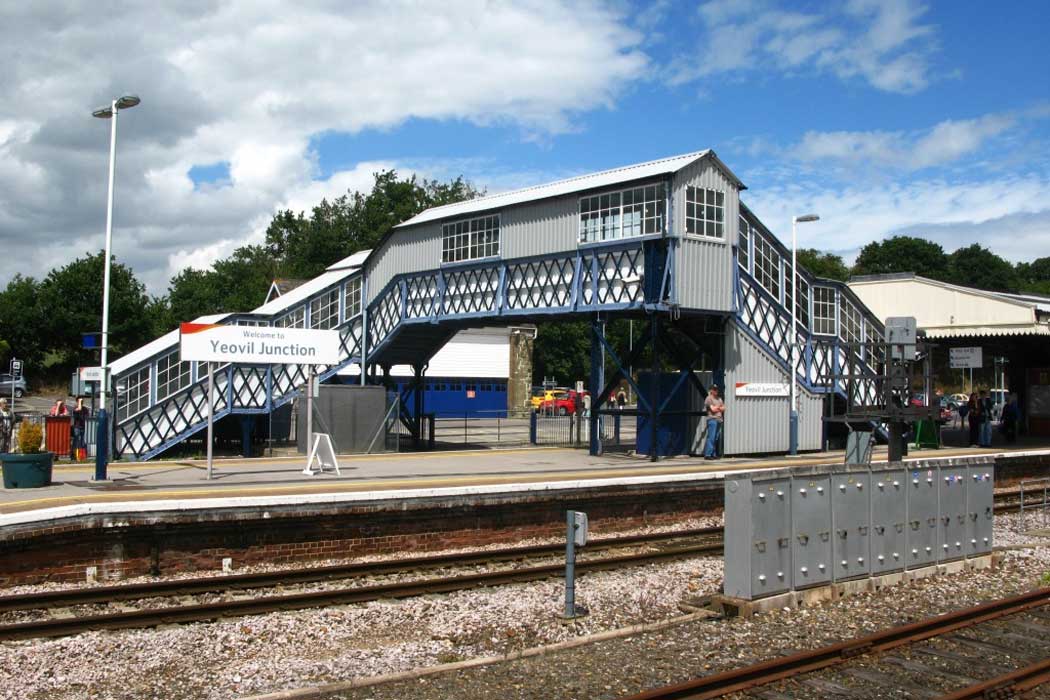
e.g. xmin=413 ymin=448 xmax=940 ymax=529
xmin=832 ymin=470 xmax=872 ymax=580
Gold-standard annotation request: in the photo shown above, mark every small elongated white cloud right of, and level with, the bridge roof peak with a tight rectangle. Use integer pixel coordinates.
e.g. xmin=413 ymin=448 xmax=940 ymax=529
xmin=782 ymin=114 xmax=1016 ymax=170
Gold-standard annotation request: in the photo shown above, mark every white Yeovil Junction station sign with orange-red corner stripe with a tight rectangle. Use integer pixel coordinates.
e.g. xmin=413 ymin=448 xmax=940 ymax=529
xmin=179 ymin=323 xmax=342 ymax=364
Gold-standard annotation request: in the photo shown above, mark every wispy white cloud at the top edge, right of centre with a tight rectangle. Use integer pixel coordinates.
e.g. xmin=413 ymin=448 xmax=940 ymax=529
xmin=671 ymin=0 xmax=935 ymax=93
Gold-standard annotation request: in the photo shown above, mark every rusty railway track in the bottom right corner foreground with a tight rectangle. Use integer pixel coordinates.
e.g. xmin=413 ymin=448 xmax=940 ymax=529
xmin=622 ymin=588 xmax=1050 ymax=700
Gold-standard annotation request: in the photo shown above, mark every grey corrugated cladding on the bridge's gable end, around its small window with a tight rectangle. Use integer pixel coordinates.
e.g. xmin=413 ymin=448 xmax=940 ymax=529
xmin=672 ymin=158 xmax=740 ymax=312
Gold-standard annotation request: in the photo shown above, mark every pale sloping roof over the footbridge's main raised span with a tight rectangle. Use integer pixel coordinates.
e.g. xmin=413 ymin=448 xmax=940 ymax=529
xmin=395 ymin=149 xmax=746 ymax=228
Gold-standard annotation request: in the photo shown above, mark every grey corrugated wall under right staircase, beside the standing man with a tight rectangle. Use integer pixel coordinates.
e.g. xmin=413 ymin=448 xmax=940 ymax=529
xmin=725 ymin=324 xmax=823 ymax=454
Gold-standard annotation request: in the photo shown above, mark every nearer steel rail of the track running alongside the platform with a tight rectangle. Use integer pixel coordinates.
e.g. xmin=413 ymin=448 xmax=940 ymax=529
xmin=0 ymin=543 xmax=722 ymax=640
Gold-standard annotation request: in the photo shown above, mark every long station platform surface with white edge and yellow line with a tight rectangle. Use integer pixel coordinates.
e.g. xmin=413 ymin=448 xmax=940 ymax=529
xmin=0 ymin=443 xmax=1050 ymax=528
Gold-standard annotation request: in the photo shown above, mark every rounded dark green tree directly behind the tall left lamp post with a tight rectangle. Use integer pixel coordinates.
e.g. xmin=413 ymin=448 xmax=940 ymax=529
xmin=35 ymin=251 xmax=156 ymax=369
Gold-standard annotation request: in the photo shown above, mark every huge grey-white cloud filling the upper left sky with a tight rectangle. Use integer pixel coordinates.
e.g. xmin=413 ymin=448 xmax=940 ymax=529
xmin=0 ymin=0 xmax=648 ymax=293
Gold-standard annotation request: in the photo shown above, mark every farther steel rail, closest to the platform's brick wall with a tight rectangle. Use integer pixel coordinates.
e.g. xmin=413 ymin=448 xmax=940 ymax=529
xmin=0 ymin=527 xmax=722 ymax=612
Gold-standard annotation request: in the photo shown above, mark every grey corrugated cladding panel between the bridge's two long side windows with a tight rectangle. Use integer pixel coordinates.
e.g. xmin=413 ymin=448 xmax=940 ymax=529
xmin=500 ymin=194 xmax=580 ymax=260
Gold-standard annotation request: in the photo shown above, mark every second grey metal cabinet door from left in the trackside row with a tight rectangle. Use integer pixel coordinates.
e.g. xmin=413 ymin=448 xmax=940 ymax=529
xmin=791 ymin=474 xmax=832 ymax=588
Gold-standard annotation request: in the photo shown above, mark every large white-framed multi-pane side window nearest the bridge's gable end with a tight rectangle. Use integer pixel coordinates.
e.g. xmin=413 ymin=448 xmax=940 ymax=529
xmin=580 ymin=183 xmax=667 ymax=243
